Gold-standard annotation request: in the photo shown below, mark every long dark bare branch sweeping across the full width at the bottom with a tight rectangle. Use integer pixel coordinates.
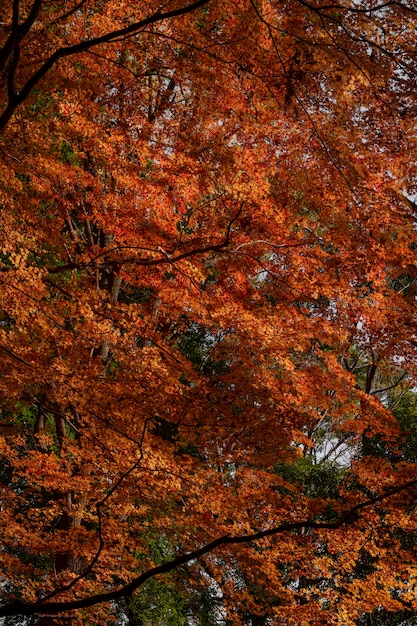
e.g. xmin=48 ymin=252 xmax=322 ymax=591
xmin=0 ymin=478 xmax=417 ymax=617
